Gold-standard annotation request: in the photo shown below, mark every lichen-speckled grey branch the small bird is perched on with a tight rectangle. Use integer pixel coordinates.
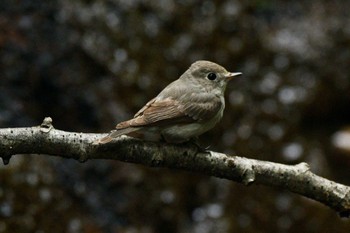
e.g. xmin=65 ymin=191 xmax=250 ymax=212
xmin=0 ymin=118 xmax=350 ymax=217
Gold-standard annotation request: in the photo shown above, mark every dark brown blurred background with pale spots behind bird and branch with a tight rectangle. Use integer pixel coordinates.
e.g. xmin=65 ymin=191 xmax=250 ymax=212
xmin=0 ymin=0 xmax=350 ymax=233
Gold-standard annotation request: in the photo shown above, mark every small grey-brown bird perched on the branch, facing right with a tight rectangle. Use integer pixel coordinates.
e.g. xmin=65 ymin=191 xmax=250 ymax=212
xmin=93 ymin=60 xmax=242 ymax=145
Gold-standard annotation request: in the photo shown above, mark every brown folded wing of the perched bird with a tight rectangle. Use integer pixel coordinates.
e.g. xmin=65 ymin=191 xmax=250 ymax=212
xmin=116 ymin=95 xmax=222 ymax=130
